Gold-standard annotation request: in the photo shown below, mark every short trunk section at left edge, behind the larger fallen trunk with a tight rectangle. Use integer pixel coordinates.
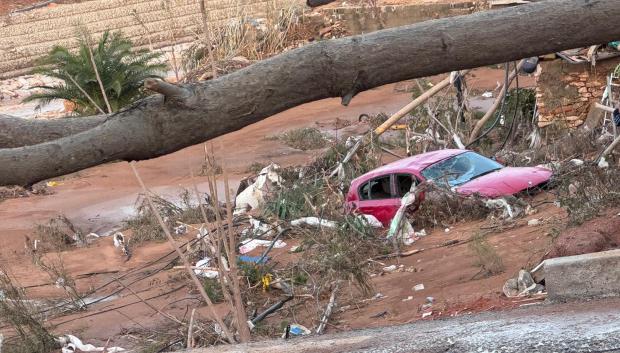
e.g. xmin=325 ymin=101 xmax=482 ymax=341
xmin=0 ymin=114 xmax=106 ymax=149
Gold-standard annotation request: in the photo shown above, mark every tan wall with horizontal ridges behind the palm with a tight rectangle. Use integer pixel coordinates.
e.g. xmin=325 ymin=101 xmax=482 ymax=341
xmin=0 ymin=0 xmax=304 ymax=79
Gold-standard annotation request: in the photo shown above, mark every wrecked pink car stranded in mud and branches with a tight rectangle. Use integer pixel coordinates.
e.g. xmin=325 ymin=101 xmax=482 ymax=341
xmin=346 ymin=150 xmax=552 ymax=226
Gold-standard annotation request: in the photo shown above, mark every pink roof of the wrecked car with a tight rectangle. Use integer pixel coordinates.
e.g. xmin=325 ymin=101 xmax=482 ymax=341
xmin=351 ymin=149 xmax=469 ymax=185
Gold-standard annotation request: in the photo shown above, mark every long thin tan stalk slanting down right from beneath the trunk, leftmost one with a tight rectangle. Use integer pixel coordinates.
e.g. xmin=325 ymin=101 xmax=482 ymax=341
xmin=130 ymin=162 xmax=235 ymax=343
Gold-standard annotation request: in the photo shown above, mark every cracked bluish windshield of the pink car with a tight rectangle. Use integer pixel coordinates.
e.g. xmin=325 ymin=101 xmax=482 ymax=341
xmin=422 ymin=152 xmax=503 ymax=187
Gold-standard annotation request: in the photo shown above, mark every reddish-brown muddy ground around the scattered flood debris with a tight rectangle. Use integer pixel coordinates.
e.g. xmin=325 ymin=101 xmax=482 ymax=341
xmin=0 ymin=68 xmax=618 ymax=347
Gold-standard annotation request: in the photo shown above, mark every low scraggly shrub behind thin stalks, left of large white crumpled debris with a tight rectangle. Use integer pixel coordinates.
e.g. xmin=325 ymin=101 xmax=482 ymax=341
xmin=125 ymin=190 xmax=215 ymax=246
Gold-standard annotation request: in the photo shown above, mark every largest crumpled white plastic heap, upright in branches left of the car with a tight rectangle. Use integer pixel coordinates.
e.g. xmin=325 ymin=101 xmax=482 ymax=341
xmin=234 ymin=163 xmax=282 ymax=215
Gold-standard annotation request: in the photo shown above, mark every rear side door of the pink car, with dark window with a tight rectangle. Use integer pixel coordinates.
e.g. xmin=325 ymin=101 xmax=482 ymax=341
xmin=358 ymin=174 xmax=400 ymax=226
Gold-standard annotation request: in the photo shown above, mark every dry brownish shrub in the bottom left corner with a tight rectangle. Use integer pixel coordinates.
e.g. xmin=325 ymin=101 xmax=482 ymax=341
xmin=0 ymin=269 xmax=58 ymax=353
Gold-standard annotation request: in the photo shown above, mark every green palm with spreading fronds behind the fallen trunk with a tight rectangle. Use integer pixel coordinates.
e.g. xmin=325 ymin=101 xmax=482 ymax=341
xmin=24 ymin=31 xmax=166 ymax=115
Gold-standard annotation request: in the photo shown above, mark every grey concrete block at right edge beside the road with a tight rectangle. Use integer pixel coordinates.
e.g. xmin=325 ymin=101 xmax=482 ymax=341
xmin=544 ymin=250 xmax=620 ymax=301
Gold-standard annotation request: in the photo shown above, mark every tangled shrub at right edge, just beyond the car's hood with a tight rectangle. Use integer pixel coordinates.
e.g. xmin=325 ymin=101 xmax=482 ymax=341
xmin=553 ymin=163 xmax=620 ymax=225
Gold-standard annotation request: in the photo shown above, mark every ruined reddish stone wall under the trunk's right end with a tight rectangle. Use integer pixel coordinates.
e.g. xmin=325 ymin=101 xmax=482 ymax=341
xmin=536 ymin=60 xmax=620 ymax=128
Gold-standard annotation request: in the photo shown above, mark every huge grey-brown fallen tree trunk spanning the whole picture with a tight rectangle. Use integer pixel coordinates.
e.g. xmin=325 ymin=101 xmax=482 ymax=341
xmin=0 ymin=0 xmax=620 ymax=185
